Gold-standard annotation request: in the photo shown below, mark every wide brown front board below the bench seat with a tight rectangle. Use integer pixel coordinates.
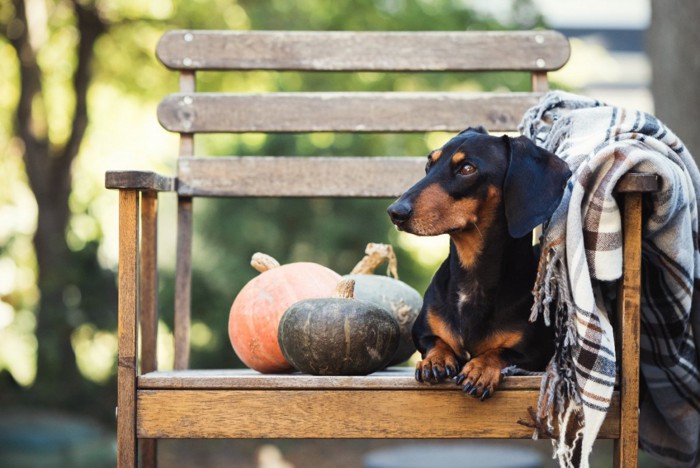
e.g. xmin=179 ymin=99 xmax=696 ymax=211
xmin=138 ymin=389 xmax=620 ymax=439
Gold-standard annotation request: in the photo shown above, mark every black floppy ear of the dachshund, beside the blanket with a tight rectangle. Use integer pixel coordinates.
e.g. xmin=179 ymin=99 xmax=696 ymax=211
xmin=503 ymin=136 xmax=571 ymax=238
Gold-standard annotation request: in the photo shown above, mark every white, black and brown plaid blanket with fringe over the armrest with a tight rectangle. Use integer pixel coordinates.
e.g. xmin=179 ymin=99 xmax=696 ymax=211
xmin=520 ymin=92 xmax=700 ymax=467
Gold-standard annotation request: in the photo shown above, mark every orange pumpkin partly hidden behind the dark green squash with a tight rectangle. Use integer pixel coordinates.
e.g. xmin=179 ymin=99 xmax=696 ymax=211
xmin=228 ymin=253 xmax=340 ymax=373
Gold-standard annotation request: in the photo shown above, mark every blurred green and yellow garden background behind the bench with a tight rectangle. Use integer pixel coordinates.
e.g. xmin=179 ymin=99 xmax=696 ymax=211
xmin=0 ymin=0 xmax=700 ymax=466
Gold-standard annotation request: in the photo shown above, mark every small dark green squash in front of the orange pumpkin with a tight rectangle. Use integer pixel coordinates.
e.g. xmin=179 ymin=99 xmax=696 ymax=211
xmin=277 ymin=280 xmax=399 ymax=375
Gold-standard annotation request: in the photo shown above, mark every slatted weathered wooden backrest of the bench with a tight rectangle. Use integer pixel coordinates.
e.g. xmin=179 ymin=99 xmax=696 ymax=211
xmin=157 ymin=31 xmax=569 ymax=369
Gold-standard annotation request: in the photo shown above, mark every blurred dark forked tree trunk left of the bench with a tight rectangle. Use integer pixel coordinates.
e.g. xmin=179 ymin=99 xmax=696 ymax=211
xmin=10 ymin=0 xmax=106 ymax=408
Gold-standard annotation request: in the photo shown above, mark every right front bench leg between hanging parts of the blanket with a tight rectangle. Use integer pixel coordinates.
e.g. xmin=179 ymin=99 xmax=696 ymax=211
xmin=614 ymin=193 xmax=642 ymax=467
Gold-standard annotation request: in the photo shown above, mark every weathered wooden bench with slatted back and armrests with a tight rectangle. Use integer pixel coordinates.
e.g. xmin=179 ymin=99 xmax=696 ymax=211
xmin=106 ymin=31 xmax=656 ymax=467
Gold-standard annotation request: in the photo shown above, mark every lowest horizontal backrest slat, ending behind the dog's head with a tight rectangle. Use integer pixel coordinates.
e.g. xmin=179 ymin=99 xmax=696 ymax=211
xmin=177 ymin=156 xmax=426 ymax=198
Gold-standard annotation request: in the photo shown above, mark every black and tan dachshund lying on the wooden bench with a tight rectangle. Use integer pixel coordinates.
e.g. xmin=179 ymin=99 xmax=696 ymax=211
xmin=388 ymin=127 xmax=571 ymax=400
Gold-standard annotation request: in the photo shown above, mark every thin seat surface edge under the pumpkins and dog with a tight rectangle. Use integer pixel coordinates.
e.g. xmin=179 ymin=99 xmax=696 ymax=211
xmin=138 ymin=367 xmax=540 ymax=391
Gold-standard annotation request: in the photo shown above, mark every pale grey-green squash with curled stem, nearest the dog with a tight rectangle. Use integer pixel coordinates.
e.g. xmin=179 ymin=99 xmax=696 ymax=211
xmin=343 ymin=243 xmax=423 ymax=366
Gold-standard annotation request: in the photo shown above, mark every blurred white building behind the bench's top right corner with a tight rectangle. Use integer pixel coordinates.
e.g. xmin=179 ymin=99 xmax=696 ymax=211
xmin=469 ymin=0 xmax=654 ymax=112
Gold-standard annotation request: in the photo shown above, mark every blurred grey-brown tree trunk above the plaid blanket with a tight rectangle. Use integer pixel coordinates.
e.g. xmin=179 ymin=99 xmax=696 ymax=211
xmin=647 ymin=0 xmax=700 ymax=161
